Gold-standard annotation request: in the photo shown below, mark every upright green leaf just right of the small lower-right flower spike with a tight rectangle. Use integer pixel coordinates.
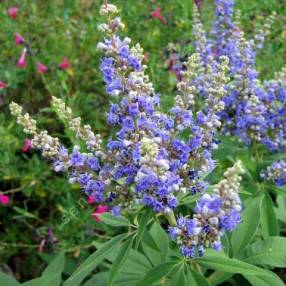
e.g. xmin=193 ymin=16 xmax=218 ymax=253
xmin=231 ymin=196 xmax=263 ymax=256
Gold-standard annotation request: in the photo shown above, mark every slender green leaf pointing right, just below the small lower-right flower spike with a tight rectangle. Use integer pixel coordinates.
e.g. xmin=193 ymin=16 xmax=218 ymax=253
xmin=196 ymin=256 xmax=272 ymax=275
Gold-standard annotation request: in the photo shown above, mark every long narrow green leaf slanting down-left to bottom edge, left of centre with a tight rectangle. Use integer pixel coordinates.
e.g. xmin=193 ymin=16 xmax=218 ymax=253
xmin=64 ymin=234 xmax=126 ymax=286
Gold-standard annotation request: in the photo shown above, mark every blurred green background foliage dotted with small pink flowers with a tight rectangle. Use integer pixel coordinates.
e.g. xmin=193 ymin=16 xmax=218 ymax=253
xmin=0 ymin=0 xmax=286 ymax=281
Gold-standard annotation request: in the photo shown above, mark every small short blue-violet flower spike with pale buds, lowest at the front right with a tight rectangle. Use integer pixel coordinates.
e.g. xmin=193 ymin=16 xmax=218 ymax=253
xmin=169 ymin=161 xmax=244 ymax=258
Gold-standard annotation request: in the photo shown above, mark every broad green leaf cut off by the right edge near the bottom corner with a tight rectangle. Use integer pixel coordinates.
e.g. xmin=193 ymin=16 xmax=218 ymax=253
xmin=244 ymin=237 xmax=286 ymax=267
